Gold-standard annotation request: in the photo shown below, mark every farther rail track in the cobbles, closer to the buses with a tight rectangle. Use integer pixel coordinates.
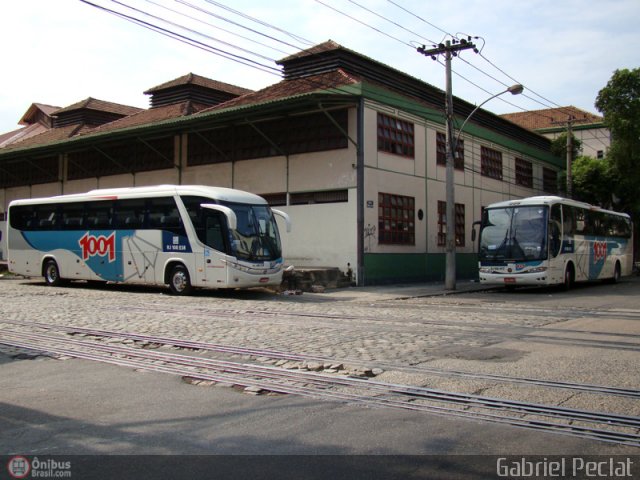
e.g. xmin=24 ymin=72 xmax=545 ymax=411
xmin=5 ymin=320 xmax=640 ymax=400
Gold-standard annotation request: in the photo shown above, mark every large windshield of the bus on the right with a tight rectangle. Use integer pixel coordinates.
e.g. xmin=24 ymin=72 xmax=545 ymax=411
xmin=479 ymin=206 xmax=548 ymax=264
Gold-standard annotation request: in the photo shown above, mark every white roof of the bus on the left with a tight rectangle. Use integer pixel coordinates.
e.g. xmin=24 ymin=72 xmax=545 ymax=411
xmin=10 ymin=185 xmax=267 ymax=205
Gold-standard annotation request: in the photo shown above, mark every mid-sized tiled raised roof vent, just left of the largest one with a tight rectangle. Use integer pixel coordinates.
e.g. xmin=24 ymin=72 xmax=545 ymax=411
xmin=144 ymin=73 xmax=252 ymax=108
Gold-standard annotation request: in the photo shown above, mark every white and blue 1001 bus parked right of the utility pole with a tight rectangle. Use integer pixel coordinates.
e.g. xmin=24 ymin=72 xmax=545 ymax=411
xmin=474 ymin=196 xmax=633 ymax=289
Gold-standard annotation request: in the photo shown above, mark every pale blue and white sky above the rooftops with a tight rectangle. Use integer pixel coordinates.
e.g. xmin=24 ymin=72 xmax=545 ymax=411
xmin=0 ymin=0 xmax=640 ymax=133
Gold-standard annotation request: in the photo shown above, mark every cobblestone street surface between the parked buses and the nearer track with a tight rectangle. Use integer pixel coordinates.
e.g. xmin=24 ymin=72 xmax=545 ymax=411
xmin=0 ymin=279 xmax=640 ymax=424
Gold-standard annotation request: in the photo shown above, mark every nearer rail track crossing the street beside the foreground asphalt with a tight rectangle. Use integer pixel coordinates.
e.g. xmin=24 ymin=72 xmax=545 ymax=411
xmin=0 ymin=321 xmax=640 ymax=446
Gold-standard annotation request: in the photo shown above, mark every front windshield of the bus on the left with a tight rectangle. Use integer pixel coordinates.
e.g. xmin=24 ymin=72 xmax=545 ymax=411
xmin=226 ymin=202 xmax=282 ymax=261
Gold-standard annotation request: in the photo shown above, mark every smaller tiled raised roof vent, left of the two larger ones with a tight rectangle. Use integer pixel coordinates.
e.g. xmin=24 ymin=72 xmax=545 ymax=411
xmin=53 ymin=97 xmax=142 ymax=128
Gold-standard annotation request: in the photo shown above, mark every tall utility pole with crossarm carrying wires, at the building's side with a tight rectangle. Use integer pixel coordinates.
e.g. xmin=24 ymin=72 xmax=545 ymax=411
xmin=417 ymin=39 xmax=477 ymax=290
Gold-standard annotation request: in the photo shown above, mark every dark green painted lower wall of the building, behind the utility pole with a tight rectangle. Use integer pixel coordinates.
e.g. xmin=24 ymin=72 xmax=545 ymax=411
xmin=364 ymin=253 xmax=478 ymax=285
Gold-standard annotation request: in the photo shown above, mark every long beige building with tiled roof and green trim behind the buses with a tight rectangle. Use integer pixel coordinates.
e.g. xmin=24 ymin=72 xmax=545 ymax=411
xmin=0 ymin=41 xmax=563 ymax=285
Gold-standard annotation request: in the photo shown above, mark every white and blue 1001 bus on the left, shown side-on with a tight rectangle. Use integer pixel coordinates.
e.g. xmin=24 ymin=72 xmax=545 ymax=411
xmin=7 ymin=185 xmax=290 ymax=295
